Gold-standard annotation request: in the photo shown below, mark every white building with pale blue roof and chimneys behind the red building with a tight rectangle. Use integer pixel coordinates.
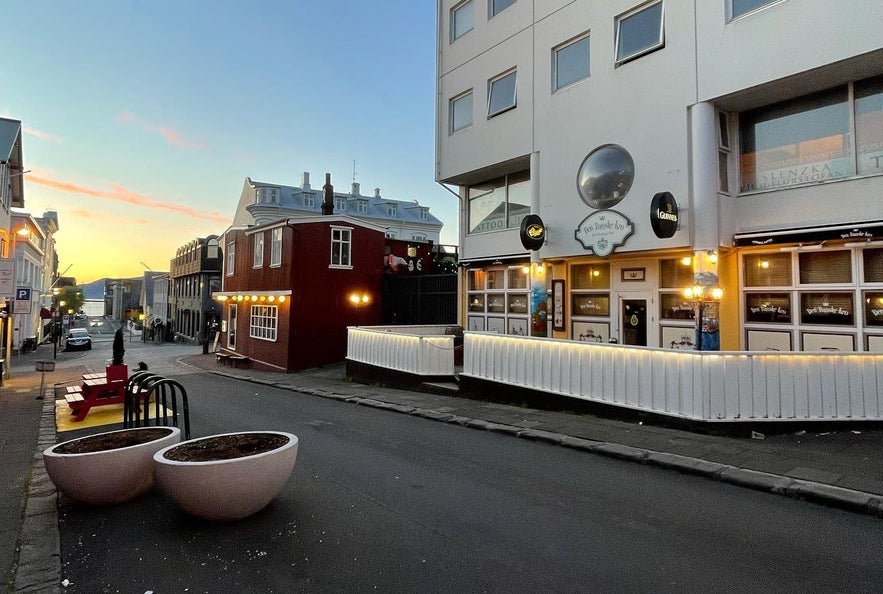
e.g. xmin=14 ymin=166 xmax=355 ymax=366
xmin=233 ymin=172 xmax=443 ymax=245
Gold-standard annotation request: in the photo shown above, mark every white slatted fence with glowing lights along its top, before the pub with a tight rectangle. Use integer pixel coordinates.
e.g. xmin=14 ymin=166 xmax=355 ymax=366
xmin=347 ymin=326 xmax=883 ymax=422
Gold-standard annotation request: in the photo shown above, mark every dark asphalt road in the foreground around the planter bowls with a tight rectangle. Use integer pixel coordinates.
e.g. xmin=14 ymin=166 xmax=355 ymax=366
xmin=59 ymin=373 xmax=883 ymax=594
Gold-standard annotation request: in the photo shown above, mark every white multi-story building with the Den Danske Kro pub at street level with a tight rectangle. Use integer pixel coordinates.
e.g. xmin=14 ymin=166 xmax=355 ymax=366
xmin=436 ymin=0 xmax=883 ymax=351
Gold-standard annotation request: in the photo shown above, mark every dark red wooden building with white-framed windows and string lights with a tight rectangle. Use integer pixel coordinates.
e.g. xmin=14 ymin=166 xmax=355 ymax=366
xmin=214 ymin=215 xmax=388 ymax=371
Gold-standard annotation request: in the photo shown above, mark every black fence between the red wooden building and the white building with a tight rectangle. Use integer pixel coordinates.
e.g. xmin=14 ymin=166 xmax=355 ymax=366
xmin=382 ymin=274 xmax=457 ymax=325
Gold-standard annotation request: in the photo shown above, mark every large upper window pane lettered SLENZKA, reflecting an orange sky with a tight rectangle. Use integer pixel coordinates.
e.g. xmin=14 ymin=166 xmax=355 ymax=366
xmin=739 ymin=87 xmax=855 ymax=192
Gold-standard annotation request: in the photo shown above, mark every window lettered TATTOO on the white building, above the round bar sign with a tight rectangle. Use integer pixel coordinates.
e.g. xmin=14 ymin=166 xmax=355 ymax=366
xmin=467 ymin=171 xmax=530 ymax=234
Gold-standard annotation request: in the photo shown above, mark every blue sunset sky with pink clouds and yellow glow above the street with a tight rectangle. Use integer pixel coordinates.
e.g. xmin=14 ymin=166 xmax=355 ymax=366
xmin=0 ymin=0 xmax=458 ymax=284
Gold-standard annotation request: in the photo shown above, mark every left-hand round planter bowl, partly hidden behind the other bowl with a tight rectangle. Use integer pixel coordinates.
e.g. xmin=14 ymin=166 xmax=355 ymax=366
xmin=43 ymin=427 xmax=181 ymax=505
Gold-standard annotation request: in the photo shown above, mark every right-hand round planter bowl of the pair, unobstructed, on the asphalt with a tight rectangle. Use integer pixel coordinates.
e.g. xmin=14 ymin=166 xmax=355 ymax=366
xmin=153 ymin=431 xmax=298 ymax=521
